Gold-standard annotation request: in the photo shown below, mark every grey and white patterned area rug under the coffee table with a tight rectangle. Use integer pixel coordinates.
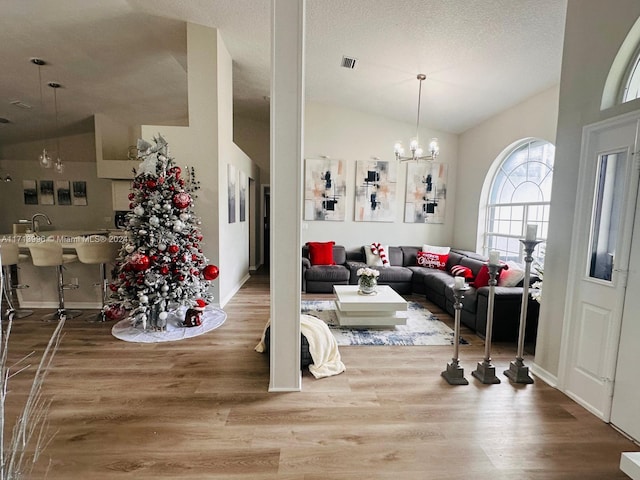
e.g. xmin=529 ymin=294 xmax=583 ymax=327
xmin=301 ymin=300 xmax=468 ymax=346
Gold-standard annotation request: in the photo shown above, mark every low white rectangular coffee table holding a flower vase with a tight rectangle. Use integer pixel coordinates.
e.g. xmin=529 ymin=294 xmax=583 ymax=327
xmin=333 ymin=285 xmax=407 ymax=328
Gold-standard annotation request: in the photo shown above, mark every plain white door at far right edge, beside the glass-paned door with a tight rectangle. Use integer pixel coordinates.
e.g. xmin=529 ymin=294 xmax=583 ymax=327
xmin=611 ymin=185 xmax=640 ymax=442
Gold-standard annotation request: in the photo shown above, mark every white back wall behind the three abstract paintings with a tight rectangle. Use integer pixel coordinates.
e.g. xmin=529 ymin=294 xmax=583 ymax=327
xmin=301 ymin=102 xmax=458 ymax=248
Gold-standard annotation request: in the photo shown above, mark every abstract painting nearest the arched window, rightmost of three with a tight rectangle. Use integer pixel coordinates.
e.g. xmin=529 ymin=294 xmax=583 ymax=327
xmin=404 ymin=162 xmax=447 ymax=223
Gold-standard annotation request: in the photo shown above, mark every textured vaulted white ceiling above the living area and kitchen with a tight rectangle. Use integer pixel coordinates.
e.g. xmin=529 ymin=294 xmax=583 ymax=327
xmin=0 ymin=0 xmax=566 ymax=143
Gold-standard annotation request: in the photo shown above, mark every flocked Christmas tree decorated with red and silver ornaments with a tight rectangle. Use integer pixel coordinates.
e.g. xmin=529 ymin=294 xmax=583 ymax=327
xmin=107 ymin=135 xmax=218 ymax=330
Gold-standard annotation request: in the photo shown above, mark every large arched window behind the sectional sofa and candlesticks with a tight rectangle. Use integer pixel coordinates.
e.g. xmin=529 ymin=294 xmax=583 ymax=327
xmin=483 ymin=140 xmax=555 ymax=263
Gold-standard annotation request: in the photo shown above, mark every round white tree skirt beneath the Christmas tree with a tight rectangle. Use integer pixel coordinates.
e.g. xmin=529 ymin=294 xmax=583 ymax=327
xmin=111 ymin=305 xmax=227 ymax=343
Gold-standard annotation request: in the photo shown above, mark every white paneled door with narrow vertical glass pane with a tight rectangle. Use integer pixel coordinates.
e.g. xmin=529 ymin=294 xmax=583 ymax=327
xmin=560 ymin=117 xmax=638 ymax=421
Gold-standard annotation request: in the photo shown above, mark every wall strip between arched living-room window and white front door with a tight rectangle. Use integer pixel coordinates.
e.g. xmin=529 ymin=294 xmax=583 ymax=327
xmin=536 ymin=0 xmax=640 ymax=378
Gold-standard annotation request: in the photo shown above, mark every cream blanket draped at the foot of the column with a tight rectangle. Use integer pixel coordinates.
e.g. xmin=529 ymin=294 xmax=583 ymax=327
xmin=255 ymin=314 xmax=346 ymax=378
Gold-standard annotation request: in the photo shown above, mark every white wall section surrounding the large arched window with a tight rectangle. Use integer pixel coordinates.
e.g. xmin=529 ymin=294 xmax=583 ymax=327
xmin=453 ymin=86 xmax=559 ymax=250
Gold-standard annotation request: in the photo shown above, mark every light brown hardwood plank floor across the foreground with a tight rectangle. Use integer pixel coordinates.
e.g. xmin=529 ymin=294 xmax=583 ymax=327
xmin=2 ymin=275 xmax=640 ymax=480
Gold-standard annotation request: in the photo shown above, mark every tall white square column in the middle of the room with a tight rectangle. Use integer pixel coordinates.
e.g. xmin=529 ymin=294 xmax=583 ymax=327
xmin=269 ymin=0 xmax=305 ymax=392
